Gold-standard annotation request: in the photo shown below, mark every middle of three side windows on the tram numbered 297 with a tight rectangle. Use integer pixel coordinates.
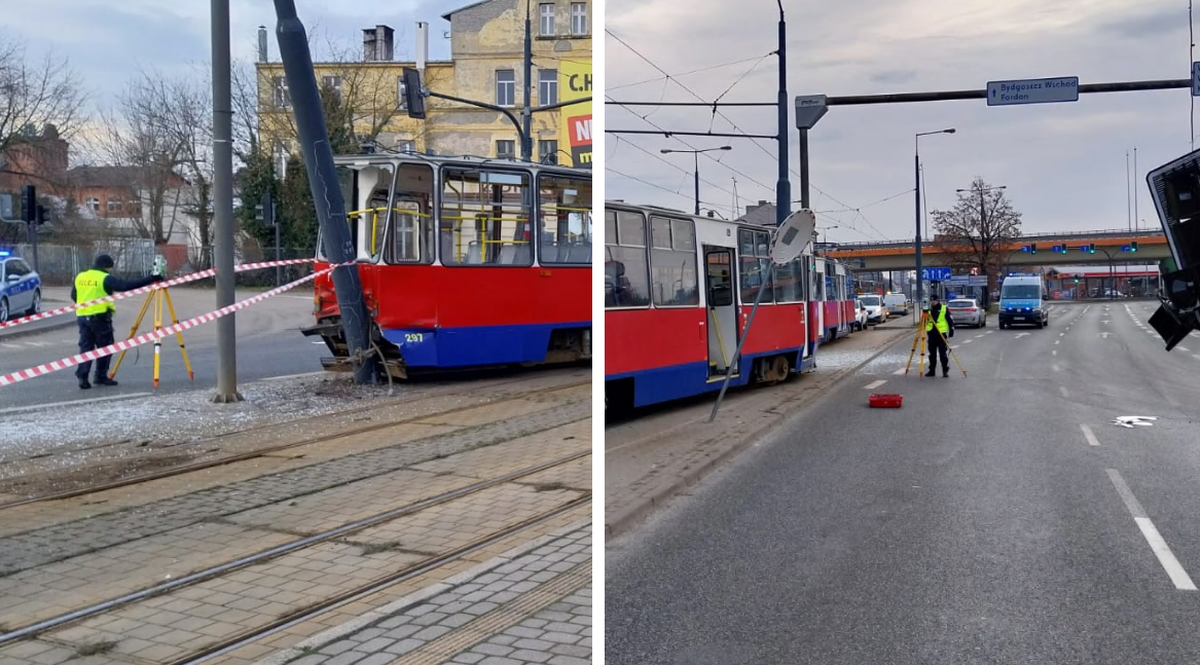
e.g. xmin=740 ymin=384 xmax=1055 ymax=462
xmin=438 ymin=168 xmax=533 ymax=266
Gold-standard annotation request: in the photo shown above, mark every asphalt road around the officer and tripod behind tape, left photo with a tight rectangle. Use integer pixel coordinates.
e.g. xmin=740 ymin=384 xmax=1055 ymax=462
xmin=0 ymin=288 xmax=329 ymax=408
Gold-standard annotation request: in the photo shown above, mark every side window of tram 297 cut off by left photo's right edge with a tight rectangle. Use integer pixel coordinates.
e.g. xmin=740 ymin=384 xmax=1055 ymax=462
xmin=538 ymin=174 xmax=592 ymax=266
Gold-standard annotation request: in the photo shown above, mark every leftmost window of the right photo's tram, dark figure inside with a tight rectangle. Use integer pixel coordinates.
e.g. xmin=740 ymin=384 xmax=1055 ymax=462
xmin=604 ymin=210 xmax=650 ymax=308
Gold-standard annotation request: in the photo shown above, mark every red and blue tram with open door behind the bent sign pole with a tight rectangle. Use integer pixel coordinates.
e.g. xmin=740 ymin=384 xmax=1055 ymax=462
xmin=605 ymin=202 xmax=854 ymax=407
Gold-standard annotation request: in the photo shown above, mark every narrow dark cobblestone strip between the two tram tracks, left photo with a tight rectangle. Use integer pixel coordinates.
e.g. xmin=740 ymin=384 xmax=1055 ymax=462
xmin=0 ymin=400 xmax=592 ymax=576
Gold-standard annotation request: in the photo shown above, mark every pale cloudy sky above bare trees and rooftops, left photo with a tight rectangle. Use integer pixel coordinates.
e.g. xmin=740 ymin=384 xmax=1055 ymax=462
xmin=0 ymin=0 xmax=472 ymax=132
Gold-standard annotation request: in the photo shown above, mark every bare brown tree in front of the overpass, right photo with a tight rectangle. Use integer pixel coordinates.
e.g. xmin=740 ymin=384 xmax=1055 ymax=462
xmin=931 ymin=176 xmax=1021 ymax=304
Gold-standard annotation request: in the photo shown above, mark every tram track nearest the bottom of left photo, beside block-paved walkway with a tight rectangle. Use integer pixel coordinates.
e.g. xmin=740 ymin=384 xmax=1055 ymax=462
xmin=0 ymin=450 xmax=592 ymax=655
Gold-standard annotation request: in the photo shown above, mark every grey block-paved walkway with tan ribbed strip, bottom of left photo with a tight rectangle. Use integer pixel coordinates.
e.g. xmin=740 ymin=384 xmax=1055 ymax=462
xmin=257 ymin=525 xmax=592 ymax=665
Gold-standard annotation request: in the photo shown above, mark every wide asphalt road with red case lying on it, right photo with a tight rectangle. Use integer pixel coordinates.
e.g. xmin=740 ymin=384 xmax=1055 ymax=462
xmin=605 ymin=301 xmax=1200 ymax=665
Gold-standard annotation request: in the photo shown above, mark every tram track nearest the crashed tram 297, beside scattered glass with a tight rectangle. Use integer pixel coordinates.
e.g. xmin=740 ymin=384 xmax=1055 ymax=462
xmin=0 ymin=372 xmax=590 ymax=511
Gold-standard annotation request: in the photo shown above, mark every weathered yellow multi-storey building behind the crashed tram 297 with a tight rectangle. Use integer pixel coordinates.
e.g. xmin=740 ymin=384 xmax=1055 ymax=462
xmin=258 ymin=0 xmax=592 ymax=173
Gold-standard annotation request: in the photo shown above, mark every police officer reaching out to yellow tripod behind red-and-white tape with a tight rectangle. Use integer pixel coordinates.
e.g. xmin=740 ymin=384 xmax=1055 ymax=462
xmin=71 ymin=254 xmax=163 ymax=390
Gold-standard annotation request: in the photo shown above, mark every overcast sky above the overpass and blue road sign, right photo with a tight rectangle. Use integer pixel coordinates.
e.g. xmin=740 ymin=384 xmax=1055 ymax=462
xmin=605 ymin=0 xmax=1200 ymax=241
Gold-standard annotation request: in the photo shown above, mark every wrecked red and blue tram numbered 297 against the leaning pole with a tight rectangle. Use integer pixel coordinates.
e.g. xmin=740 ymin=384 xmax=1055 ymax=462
xmin=304 ymin=152 xmax=592 ymax=378
